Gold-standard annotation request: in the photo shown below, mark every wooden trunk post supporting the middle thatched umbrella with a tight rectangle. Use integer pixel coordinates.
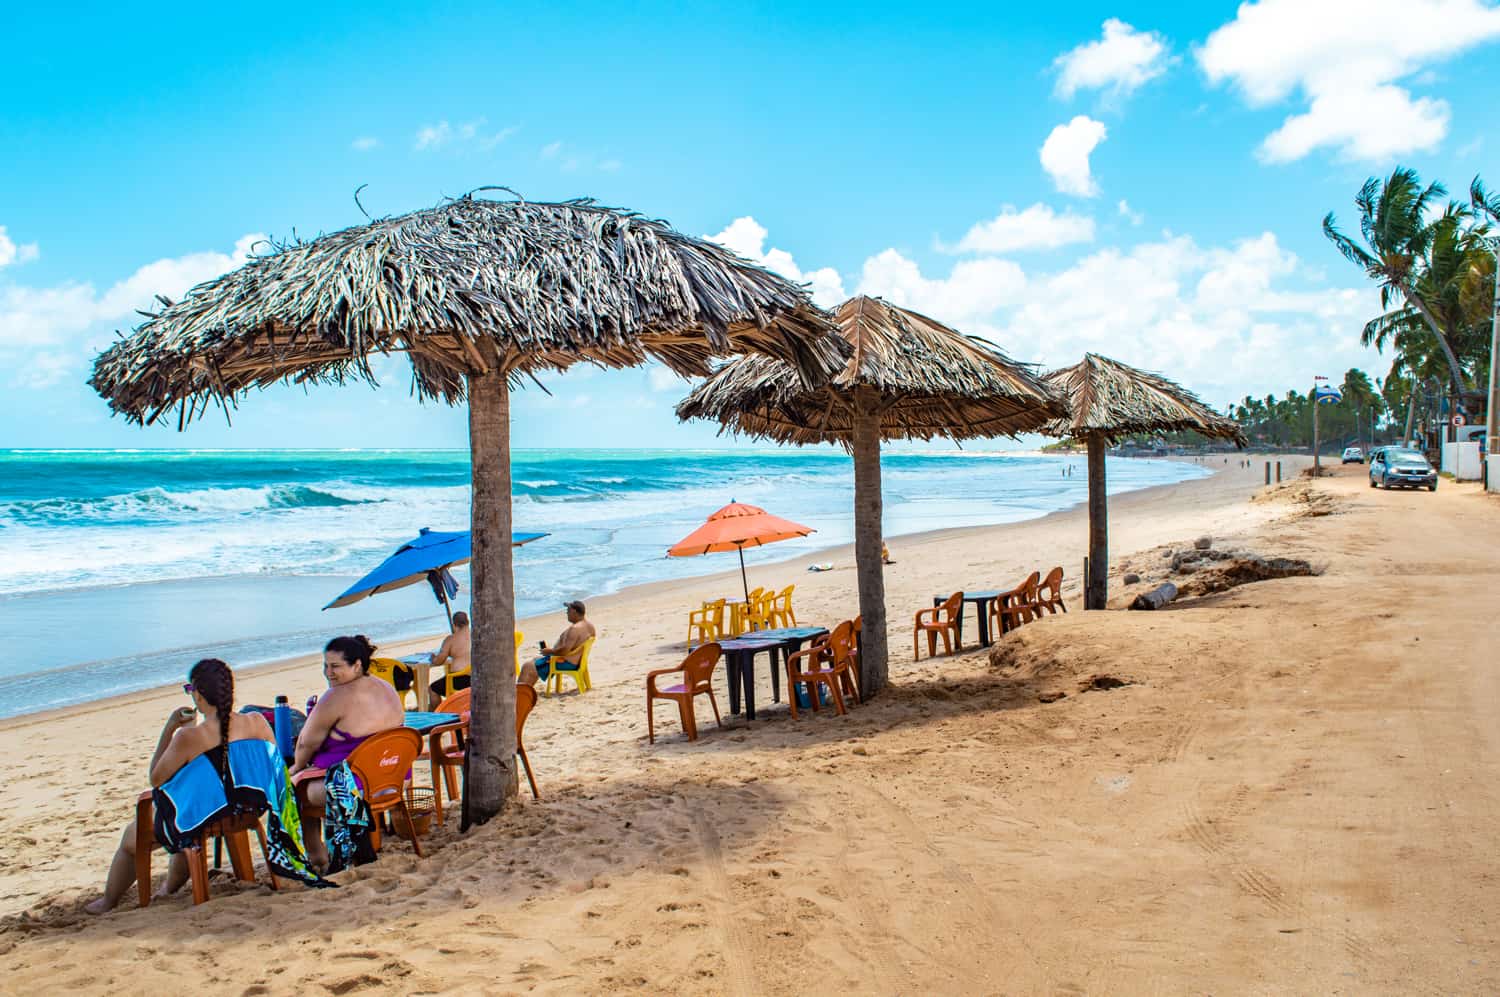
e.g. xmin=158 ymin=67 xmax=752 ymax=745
xmin=852 ymin=387 xmax=890 ymax=696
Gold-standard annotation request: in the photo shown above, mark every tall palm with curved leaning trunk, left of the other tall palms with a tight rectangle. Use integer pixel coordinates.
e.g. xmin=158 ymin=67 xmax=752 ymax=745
xmin=1323 ymin=166 xmax=1467 ymax=396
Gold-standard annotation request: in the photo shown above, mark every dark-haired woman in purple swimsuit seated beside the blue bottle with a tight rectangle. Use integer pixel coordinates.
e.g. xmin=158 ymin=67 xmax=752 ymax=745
xmin=291 ymin=634 xmax=405 ymax=868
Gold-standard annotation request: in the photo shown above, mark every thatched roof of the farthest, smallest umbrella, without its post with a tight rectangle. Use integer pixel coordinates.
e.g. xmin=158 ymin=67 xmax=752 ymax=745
xmin=1041 ymin=354 xmax=1250 ymax=447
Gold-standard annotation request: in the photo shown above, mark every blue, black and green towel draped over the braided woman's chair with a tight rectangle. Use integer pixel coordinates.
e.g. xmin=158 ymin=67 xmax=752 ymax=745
xmin=152 ymin=739 xmax=336 ymax=888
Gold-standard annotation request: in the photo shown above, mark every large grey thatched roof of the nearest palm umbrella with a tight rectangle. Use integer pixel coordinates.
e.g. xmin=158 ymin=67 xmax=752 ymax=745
xmin=90 ymin=193 xmax=840 ymax=423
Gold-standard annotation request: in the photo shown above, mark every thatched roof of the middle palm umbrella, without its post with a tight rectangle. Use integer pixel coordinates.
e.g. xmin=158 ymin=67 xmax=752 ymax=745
xmin=677 ymin=295 xmax=1067 ymax=444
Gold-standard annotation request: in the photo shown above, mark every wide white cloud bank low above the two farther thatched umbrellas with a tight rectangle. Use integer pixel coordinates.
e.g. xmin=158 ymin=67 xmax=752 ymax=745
xmin=834 ymin=214 xmax=1386 ymax=406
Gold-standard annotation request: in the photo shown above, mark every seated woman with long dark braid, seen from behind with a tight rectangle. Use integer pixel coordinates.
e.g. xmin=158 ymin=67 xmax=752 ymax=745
xmin=84 ymin=658 xmax=279 ymax=915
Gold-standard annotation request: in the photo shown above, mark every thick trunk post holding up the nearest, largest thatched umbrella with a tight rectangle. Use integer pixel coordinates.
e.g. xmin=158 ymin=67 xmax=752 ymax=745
xmin=468 ymin=370 xmax=516 ymax=823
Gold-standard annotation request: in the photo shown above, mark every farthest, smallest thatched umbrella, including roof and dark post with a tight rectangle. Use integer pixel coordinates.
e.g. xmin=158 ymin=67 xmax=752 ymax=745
xmin=1043 ymin=354 xmax=1250 ymax=609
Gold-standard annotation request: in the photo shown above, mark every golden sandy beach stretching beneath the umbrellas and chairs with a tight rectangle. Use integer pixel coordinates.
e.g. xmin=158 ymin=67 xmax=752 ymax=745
xmin=0 ymin=456 xmax=1500 ymax=994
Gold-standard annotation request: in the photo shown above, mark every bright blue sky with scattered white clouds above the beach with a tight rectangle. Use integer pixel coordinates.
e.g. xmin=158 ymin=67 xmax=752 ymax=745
xmin=0 ymin=0 xmax=1500 ymax=447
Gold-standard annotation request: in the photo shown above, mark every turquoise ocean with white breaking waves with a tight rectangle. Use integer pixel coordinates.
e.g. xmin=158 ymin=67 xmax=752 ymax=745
xmin=0 ymin=450 xmax=1208 ymax=717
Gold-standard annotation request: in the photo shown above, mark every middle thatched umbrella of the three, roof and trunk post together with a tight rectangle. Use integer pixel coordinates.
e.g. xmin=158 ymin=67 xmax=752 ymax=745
xmin=677 ymin=297 xmax=1067 ymax=691
